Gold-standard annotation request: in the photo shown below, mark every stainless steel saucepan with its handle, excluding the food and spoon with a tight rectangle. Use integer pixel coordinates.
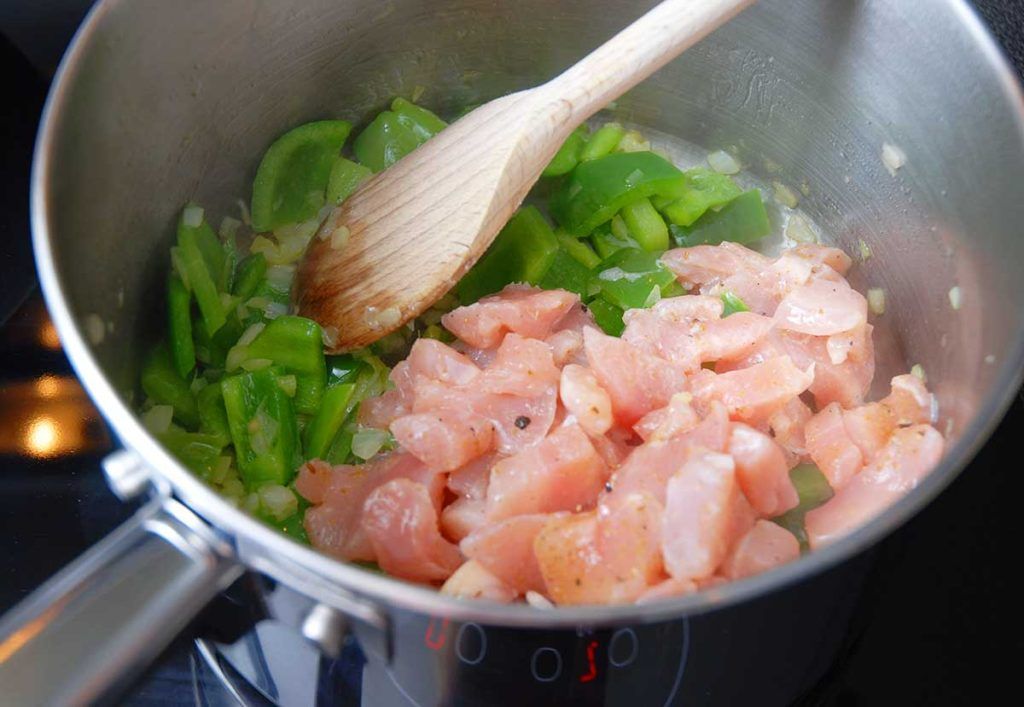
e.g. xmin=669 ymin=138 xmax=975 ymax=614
xmin=0 ymin=0 xmax=1024 ymax=704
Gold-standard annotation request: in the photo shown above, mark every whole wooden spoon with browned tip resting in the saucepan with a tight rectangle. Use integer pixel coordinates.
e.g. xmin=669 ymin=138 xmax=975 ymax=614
xmin=294 ymin=0 xmax=755 ymax=352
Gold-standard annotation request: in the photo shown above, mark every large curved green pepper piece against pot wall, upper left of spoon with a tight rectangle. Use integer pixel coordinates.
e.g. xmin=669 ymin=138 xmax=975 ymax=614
xmin=250 ymin=120 xmax=352 ymax=232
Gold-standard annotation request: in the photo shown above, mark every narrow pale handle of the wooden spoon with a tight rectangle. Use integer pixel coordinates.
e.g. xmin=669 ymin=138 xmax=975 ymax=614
xmin=541 ymin=0 xmax=756 ymax=123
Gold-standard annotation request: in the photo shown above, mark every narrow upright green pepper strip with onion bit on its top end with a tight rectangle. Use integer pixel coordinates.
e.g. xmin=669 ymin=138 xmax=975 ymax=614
xmin=174 ymin=209 xmax=226 ymax=335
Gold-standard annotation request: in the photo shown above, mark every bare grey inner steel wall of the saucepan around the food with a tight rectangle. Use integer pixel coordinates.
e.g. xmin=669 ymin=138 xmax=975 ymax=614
xmin=34 ymin=0 xmax=1024 ymax=622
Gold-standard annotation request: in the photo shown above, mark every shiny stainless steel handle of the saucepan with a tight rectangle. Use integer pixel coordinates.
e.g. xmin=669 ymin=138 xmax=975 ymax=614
xmin=0 ymin=498 xmax=243 ymax=705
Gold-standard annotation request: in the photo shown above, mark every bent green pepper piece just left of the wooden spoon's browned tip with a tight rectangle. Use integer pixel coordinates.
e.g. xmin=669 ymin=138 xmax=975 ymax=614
xmin=246 ymin=315 xmax=327 ymax=415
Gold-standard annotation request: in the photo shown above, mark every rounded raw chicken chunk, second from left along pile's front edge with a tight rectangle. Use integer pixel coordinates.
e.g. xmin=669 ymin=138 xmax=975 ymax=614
xmin=361 ymin=479 xmax=462 ymax=582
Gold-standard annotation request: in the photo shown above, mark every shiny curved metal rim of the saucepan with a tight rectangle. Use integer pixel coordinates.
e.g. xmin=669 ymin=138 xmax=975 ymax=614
xmin=31 ymin=0 xmax=1024 ymax=628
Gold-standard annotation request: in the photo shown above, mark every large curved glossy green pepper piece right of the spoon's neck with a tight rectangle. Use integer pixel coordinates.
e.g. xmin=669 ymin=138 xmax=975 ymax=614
xmin=550 ymin=152 xmax=686 ymax=236
